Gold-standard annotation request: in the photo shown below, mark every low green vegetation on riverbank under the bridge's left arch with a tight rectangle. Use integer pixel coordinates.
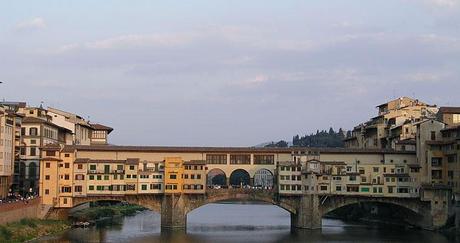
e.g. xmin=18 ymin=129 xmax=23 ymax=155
xmin=72 ymin=205 xmax=145 ymax=221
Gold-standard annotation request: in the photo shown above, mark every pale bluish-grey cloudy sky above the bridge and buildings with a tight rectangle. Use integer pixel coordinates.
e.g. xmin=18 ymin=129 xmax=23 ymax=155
xmin=0 ymin=0 xmax=460 ymax=146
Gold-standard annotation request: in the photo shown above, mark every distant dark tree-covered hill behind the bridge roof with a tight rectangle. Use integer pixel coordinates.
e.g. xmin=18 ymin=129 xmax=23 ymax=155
xmin=264 ymin=127 xmax=345 ymax=148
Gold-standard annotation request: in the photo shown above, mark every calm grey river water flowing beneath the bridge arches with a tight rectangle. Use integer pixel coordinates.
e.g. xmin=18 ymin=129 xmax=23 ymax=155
xmin=36 ymin=204 xmax=453 ymax=243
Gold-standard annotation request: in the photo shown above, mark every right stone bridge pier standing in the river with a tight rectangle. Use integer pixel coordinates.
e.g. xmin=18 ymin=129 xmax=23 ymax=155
xmin=291 ymin=194 xmax=321 ymax=229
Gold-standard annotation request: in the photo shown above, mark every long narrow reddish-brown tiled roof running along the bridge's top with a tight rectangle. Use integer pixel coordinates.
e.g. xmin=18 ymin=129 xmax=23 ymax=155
xmin=66 ymin=145 xmax=415 ymax=154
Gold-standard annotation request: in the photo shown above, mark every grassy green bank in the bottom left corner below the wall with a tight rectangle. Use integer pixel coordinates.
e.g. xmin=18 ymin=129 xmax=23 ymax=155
xmin=0 ymin=219 xmax=70 ymax=243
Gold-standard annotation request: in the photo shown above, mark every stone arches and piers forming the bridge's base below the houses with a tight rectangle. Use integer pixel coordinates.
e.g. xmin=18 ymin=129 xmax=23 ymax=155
xmin=47 ymin=189 xmax=450 ymax=229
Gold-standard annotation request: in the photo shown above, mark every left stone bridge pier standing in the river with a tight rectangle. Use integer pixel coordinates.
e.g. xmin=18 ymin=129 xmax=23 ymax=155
xmin=161 ymin=194 xmax=187 ymax=231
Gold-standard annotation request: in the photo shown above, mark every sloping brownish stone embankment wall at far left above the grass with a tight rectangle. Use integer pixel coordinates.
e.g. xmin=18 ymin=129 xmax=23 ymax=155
xmin=0 ymin=198 xmax=40 ymax=224
